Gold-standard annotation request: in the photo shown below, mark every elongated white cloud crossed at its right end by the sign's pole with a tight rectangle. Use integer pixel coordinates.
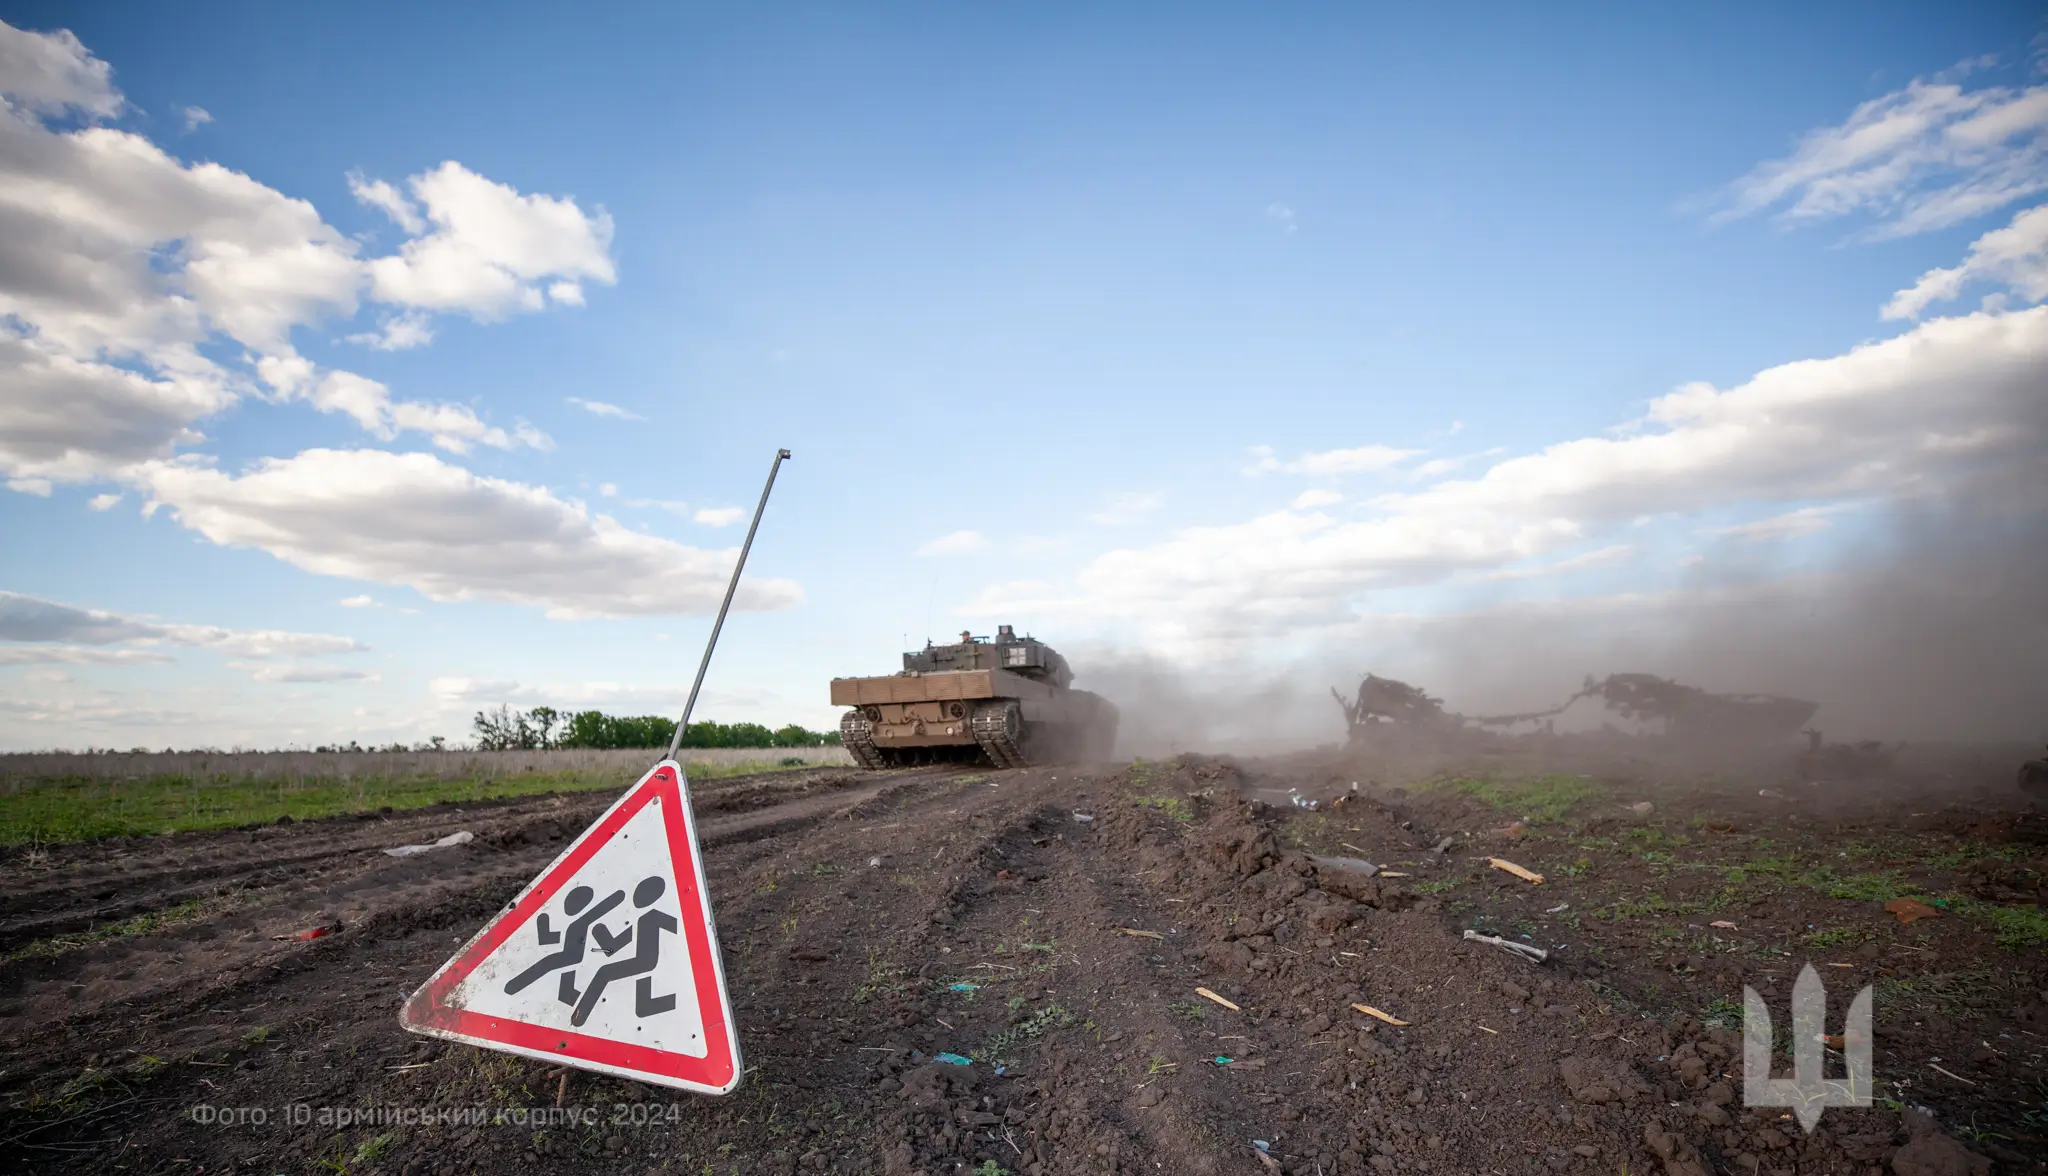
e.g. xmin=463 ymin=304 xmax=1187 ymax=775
xmin=139 ymin=449 xmax=803 ymax=617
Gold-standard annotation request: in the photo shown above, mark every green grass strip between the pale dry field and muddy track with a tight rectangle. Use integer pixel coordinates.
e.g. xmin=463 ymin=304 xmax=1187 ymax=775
xmin=0 ymin=752 xmax=809 ymax=846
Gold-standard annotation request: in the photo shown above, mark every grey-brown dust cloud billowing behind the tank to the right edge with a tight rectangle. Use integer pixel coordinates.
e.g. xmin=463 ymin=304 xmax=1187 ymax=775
xmin=1073 ymin=483 xmax=2048 ymax=756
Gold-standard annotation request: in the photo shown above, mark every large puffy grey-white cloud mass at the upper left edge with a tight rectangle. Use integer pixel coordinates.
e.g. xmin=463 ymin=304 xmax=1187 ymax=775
xmin=0 ymin=25 xmax=610 ymax=481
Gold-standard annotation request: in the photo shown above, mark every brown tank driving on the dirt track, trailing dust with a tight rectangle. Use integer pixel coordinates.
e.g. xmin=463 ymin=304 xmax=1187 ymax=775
xmin=831 ymin=625 xmax=1116 ymax=768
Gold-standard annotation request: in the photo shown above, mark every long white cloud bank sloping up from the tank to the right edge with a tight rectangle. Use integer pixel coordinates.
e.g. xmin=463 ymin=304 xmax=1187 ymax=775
xmin=967 ymin=307 xmax=2048 ymax=639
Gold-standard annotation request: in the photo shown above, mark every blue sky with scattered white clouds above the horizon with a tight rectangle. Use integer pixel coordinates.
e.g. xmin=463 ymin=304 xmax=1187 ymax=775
xmin=0 ymin=2 xmax=2048 ymax=748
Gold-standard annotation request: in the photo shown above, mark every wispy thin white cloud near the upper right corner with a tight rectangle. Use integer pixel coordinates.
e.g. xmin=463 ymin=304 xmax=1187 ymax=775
xmin=1714 ymin=70 xmax=2048 ymax=238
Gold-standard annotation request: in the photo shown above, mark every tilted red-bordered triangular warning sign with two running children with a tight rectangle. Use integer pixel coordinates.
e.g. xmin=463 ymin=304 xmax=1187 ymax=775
xmin=399 ymin=760 xmax=741 ymax=1094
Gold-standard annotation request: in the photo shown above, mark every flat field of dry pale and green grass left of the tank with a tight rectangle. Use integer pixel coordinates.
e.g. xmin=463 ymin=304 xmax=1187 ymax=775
xmin=0 ymin=748 xmax=850 ymax=846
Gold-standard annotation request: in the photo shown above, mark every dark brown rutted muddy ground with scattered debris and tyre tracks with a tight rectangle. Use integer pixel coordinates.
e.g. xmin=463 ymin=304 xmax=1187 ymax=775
xmin=0 ymin=752 xmax=2048 ymax=1176
